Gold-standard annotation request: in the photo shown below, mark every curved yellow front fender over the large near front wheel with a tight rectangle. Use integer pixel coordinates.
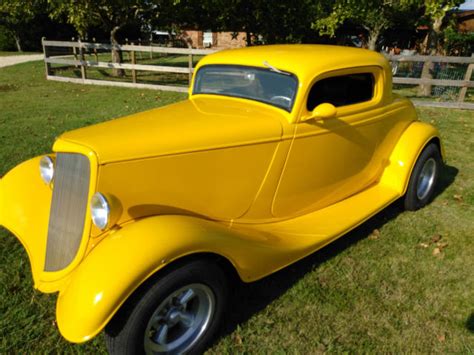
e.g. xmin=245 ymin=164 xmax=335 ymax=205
xmin=56 ymin=216 xmax=285 ymax=343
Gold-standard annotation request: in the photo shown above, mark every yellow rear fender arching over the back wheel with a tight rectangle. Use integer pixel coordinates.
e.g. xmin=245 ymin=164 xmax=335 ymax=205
xmin=380 ymin=121 xmax=444 ymax=196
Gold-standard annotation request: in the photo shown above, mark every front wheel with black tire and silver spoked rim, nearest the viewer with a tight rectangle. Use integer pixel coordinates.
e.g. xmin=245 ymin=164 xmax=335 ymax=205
xmin=105 ymin=260 xmax=227 ymax=355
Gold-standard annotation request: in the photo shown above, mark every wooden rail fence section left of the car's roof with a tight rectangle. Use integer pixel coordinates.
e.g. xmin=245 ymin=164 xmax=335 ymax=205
xmin=42 ymin=38 xmax=215 ymax=92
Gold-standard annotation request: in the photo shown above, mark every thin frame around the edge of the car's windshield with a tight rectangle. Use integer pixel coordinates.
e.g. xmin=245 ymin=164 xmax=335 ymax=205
xmin=192 ymin=64 xmax=299 ymax=113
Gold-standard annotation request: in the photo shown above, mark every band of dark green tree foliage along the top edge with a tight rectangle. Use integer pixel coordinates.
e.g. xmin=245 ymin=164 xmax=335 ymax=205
xmin=0 ymin=0 xmax=463 ymax=55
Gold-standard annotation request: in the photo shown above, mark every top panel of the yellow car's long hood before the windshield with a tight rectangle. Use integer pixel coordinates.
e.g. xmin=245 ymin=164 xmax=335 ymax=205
xmin=59 ymin=96 xmax=286 ymax=164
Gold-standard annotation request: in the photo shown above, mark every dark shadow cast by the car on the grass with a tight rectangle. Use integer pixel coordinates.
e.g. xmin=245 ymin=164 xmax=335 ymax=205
xmin=216 ymin=165 xmax=460 ymax=342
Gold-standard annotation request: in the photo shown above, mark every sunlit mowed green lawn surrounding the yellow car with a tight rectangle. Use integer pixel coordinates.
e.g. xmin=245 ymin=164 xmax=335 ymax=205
xmin=0 ymin=62 xmax=474 ymax=354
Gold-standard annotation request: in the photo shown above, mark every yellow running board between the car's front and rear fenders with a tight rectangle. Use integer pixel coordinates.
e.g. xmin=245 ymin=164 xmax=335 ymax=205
xmin=231 ymin=183 xmax=401 ymax=278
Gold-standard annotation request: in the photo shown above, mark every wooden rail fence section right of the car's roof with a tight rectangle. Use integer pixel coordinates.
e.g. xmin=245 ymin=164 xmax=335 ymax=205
xmin=387 ymin=55 xmax=474 ymax=110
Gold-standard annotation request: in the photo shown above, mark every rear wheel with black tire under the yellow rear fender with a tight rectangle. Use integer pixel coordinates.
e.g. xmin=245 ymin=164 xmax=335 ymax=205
xmin=404 ymin=143 xmax=442 ymax=211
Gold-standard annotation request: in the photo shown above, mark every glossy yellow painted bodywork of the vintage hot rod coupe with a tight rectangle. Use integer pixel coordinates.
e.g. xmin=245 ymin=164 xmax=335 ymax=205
xmin=0 ymin=45 xmax=438 ymax=342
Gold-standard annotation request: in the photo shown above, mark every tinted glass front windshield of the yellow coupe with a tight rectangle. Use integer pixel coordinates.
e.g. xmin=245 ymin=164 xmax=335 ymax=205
xmin=193 ymin=65 xmax=298 ymax=112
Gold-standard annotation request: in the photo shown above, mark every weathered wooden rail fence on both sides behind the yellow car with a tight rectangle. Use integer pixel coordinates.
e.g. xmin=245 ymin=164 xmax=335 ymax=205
xmin=42 ymin=38 xmax=474 ymax=109
